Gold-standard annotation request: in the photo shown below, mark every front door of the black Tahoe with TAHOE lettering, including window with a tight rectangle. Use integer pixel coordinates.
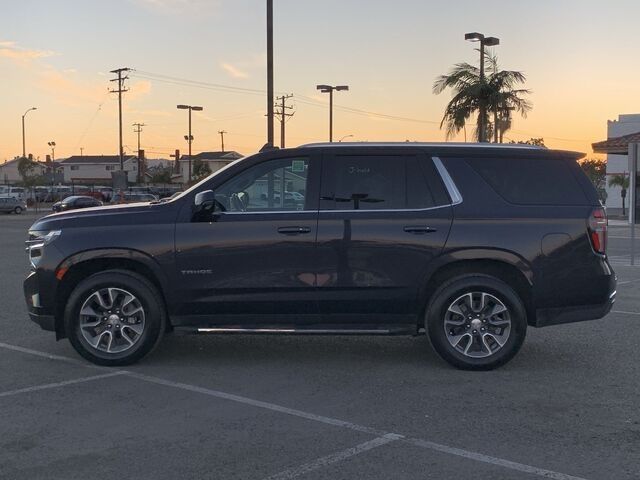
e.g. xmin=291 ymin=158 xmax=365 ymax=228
xmin=172 ymin=155 xmax=319 ymax=326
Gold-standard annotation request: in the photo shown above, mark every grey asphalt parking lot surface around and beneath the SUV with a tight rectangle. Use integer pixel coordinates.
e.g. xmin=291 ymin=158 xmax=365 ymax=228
xmin=0 ymin=214 xmax=640 ymax=480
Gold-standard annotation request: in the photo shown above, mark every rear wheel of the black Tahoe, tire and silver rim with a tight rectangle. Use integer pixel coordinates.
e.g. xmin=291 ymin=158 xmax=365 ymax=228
xmin=425 ymin=274 xmax=527 ymax=370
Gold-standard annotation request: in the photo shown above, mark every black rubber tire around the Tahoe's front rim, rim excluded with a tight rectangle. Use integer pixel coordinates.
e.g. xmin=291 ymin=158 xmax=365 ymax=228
xmin=64 ymin=270 xmax=167 ymax=366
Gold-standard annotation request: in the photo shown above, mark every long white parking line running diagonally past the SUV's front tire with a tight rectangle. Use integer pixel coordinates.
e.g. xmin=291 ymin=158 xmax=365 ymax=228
xmin=0 ymin=342 xmax=592 ymax=480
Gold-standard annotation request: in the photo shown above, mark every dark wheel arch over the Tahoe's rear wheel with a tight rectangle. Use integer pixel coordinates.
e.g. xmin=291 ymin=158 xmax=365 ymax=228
xmin=418 ymin=250 xmax=536 ymax=327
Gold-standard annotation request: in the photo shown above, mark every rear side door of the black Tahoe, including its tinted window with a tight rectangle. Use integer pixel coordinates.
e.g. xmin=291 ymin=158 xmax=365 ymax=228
xmin=317 ymin=147 xmax=452 ymax=328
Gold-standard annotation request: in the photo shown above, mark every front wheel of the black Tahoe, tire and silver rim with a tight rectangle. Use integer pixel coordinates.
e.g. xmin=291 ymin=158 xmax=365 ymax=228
xmin=65 ymin=270 xmax=166 ymax=366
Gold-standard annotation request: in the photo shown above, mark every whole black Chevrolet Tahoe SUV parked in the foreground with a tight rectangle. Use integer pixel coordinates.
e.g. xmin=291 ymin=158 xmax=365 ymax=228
xmin=24 ymin=143 xmax=616 ymax=370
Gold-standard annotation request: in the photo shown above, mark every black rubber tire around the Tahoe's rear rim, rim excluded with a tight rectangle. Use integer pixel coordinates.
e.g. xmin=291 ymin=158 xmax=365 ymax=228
xmin=425 ymin=274 xmax=527 ymax=370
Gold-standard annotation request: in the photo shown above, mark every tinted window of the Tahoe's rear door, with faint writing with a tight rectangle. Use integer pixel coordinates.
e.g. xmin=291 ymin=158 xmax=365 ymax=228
xmin=321 ymin=155 xmax=450 ymax=210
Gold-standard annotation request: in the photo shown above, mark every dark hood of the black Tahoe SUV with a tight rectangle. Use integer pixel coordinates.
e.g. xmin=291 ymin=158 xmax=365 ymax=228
xmin=30 ymin=202 xmax=181 ymax=230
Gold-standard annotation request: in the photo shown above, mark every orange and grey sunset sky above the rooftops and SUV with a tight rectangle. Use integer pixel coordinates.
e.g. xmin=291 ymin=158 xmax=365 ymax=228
xmin=0 ymin=0 xmax=640 ymax=162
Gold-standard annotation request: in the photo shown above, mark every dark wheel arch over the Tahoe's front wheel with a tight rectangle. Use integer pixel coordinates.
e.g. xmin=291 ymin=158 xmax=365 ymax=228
xmin=54 ymin=249 xmax=170 ymax=340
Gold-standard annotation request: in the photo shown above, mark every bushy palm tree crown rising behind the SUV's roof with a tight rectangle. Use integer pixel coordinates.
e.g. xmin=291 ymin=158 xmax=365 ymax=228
xmin=433 ymin=52 xmax=531 ymax=142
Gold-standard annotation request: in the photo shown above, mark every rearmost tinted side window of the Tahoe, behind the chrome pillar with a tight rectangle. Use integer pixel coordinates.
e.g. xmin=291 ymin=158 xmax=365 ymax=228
xmin=466 ymin=158 xmax=588 ymax=205
